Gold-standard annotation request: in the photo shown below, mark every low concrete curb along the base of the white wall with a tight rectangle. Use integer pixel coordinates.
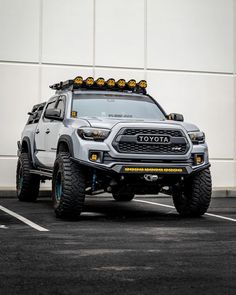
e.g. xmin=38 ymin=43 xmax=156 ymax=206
xmin=0 ymin=187 xmax=236 ymax=198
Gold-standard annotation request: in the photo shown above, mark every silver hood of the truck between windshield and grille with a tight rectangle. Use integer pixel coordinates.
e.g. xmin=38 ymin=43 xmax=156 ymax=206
xmin=80 ymin=117 xmax=199 ymax=132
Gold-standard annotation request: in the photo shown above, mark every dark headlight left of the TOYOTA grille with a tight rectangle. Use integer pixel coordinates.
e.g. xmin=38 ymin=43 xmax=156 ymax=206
xmin=77 ymin=127 xmax=110 ymax=141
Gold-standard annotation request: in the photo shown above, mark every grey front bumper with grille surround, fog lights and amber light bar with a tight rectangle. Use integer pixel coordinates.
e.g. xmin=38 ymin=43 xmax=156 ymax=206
xmin=73 ymin=123 xmax=210 ymax=175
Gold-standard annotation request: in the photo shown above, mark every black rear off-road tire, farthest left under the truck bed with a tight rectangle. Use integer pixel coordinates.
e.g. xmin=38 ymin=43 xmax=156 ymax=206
xmin=16 ymin=153 xmax=40 ymax=202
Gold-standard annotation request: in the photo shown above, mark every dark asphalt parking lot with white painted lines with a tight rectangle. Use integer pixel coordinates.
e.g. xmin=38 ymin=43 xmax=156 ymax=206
xmin=0 ymin=196 xmax=236 ymax=295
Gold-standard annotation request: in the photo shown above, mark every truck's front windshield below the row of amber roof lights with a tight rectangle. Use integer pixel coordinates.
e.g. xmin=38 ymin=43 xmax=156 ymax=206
xmin=71 ymin=93 xmax=165 ymax=120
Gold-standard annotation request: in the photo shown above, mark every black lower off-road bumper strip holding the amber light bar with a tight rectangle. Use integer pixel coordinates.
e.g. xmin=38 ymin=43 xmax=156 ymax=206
xmin=72 ymin=158 xmax=210 ymax=176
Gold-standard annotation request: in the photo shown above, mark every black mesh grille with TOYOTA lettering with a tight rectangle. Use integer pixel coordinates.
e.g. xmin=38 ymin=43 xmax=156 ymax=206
xmin=113 ymin=128 xmax=189 ymax=155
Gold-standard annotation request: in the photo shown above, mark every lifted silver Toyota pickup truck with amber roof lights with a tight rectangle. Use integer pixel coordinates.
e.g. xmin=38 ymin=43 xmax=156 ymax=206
xmin=16 ymin=76 xmax=212 ymax=218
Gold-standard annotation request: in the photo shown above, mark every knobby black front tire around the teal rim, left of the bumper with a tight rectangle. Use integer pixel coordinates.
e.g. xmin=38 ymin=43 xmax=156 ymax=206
xmin=52 ymin=153 xmax=85 ymax=219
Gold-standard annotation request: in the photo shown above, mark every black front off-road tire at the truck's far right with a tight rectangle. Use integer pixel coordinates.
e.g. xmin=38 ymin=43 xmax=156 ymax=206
xmin=173 ymin=168 xmax=212 ymax=217
